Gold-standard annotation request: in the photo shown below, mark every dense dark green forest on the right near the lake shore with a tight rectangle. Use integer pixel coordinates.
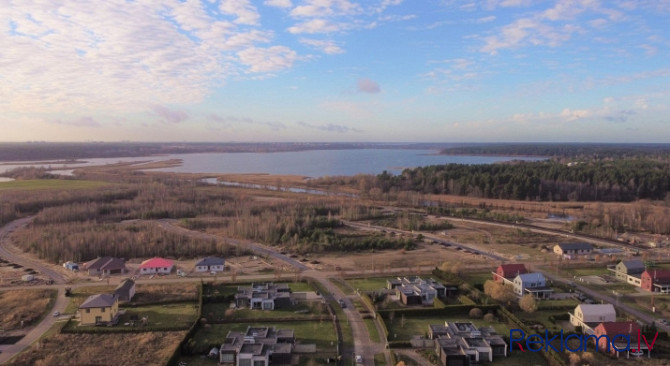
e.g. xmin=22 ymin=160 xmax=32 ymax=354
xmin=372 ymin=159 xmax=670 ymax=202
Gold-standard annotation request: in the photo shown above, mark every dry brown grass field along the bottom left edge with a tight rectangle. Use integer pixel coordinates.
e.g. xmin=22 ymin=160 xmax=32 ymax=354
xmin=10 ymin=332 xmax=186 ymax=366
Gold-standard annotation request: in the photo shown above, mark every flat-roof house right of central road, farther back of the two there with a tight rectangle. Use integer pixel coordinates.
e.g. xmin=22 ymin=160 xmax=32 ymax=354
xmin=386 ymin=277 xmax=457 ymax=305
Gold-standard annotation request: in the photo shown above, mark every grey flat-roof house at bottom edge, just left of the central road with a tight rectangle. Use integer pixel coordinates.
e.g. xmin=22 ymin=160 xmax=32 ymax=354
xmin=219 ymin=327 xmax=295 ymax=366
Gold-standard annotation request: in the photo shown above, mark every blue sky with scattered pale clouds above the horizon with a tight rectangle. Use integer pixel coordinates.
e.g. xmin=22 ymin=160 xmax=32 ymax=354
xmin=0 ymin=0 xmax=670 ymax=142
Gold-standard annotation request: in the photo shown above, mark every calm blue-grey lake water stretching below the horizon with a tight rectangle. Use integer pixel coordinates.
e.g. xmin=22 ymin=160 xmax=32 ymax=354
xmin=0 ymin=149 xmax=540 ymax=177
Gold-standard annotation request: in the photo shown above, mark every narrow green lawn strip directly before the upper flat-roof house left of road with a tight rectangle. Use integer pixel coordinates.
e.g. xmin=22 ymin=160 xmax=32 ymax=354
xmin=202 ymin=302 xmax=328 ymax=320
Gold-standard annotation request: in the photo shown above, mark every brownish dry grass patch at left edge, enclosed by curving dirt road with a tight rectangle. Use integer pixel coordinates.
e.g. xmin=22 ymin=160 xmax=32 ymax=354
xmin=0 ymin=290 xmax=54 ymax=330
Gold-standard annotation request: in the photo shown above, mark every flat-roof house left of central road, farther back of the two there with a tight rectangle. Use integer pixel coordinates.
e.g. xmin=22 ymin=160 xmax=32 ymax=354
xmin=235 ymin=282 xmax=291 ymax=310
